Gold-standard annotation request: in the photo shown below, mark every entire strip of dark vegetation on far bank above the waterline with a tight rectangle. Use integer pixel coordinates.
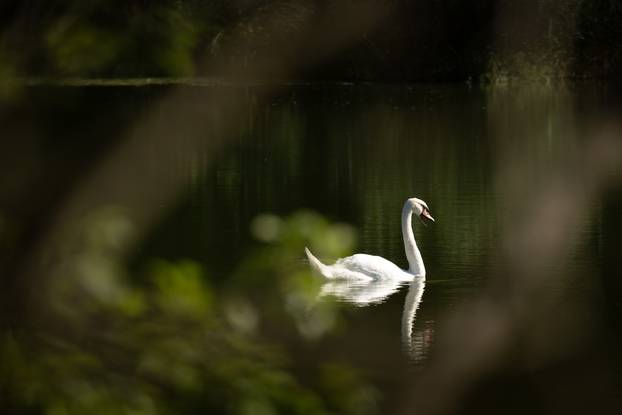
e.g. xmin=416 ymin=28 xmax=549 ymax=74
xmin=0 ymin=0 xmax=622 ymax=83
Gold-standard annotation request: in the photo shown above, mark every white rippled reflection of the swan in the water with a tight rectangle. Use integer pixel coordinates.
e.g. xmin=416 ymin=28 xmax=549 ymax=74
xmin=318 ymin=278 xmax=429 ymax=362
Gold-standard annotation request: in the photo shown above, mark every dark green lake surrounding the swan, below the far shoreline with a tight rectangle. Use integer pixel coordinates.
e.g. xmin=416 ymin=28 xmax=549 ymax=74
xmin=0 ymin=80 xmax=622 ymax=414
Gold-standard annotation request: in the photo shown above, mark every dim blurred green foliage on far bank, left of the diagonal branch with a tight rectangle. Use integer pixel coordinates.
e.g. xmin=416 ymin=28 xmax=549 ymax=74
xmin=3 ymin=0 xmax=228 ymax=77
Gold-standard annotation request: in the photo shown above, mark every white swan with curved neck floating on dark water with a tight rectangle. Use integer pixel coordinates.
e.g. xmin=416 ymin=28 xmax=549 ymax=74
xmin=305 ymin=197 xmax=434 ymax=281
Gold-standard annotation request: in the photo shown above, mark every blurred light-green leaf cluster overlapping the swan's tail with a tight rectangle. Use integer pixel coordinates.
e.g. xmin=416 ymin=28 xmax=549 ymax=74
xmin=236 ymin=211 xmax=356 ymax=340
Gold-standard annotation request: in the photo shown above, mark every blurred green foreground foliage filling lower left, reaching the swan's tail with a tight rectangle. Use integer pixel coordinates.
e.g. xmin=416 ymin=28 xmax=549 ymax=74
xmin=0 ymin=207 xmax=376 ymax=415
